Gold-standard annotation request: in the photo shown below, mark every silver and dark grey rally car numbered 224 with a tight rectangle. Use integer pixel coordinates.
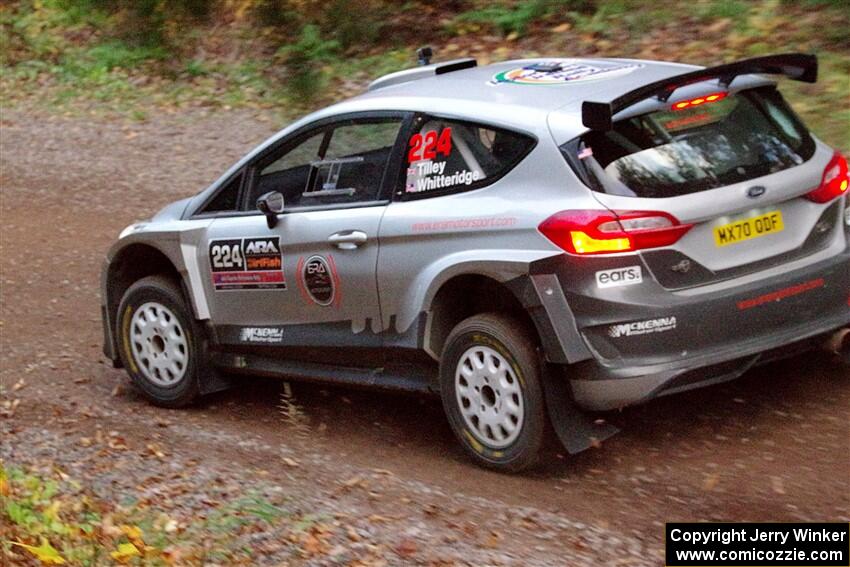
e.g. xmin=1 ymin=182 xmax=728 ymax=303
xmin=102 ymin=50 xmax=850 ymax=471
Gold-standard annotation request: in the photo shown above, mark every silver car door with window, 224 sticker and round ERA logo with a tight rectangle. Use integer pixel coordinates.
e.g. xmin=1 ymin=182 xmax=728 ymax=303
xmin=199 ymin=113 xmax=405 ymax=357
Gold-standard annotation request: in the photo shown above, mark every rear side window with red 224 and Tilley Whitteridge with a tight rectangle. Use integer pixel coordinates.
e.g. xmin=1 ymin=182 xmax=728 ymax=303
xmin=402 ymin=118 xmax=535 ymax=198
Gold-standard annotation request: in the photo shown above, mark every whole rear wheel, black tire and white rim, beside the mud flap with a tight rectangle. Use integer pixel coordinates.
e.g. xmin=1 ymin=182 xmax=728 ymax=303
xmin=440 ymin=313 xmax=546 ymax=472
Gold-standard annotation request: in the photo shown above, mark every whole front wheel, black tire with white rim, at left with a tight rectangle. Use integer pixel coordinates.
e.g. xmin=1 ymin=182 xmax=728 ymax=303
xmin=116 ymin=276 xmax=201 ymax=407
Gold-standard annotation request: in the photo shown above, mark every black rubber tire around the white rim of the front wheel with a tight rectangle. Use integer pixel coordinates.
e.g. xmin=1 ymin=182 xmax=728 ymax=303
xmin=115 ymin=275 xmax=204 ymax=408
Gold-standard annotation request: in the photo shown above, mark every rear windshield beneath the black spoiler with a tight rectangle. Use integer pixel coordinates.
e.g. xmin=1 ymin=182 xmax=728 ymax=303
xmin=561 ymin=87 xmax=815 ymax=197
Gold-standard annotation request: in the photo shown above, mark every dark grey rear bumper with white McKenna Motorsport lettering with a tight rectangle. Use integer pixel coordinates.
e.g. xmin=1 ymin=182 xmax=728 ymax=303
xmin=548 ymin=242 xmax=850 ymax=410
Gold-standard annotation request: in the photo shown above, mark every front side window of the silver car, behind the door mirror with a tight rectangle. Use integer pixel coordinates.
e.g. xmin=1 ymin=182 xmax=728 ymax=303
xmin=248 ymin=118 xmax=401 ymax=209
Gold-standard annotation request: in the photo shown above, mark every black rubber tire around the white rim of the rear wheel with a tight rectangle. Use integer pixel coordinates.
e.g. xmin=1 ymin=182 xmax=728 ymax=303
xmin=440 ymin=313 xmax=548 ymax=472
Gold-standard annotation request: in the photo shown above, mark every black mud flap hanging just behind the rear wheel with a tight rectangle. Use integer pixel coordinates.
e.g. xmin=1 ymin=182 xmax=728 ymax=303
xmin=543 ymin=371 xmax=620 ymax=455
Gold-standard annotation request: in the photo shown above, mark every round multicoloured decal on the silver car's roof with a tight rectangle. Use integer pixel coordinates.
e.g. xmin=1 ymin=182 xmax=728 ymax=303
xmin=490 ymin=59 xmax=643 ymax=85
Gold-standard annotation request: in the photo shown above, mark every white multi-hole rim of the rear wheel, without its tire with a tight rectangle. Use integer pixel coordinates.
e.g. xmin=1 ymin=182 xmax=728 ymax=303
xmin=455 ymin=346 xmax=524 ymax=449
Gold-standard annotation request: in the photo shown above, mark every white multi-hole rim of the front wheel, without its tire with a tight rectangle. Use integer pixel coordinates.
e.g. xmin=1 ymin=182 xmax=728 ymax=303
xmin=130 ymin=301 xmax=189 ymax=387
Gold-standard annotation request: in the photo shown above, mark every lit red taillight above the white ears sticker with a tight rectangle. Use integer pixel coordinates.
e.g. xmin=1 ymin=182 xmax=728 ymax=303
xmin=538 ymin=211 xmax=693 ymax=255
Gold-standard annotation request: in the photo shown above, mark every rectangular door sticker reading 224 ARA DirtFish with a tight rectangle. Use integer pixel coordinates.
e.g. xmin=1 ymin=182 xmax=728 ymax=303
xmin=210 ymin=236 xmax=286 ymax=291
